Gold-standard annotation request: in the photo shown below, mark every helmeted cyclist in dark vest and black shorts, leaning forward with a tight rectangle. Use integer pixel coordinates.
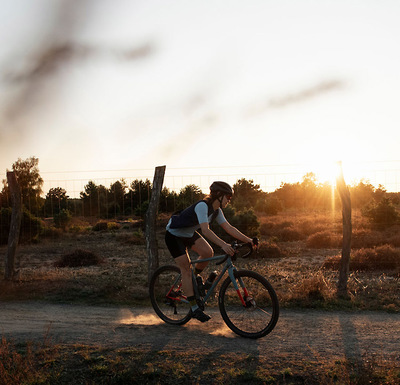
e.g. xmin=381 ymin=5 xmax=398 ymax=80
xmin=165 ymin=181 xmax=256 ymax=322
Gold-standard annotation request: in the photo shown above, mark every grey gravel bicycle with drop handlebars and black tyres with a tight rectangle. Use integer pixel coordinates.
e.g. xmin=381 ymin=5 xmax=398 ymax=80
xmin=149 ymin=242 xmax=279 ymax=338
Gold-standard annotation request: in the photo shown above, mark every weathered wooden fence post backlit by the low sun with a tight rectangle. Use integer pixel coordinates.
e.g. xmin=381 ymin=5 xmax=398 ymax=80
xmin=336 ymin=162 xmax=352 ymax=297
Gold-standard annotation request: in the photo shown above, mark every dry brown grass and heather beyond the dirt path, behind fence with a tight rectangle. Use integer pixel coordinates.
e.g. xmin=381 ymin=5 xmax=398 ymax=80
xmin=0 ymin=213 xmax=400 ymax=311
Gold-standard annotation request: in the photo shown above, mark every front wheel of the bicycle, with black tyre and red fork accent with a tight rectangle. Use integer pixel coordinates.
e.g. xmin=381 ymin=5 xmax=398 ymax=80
xmin=218 ymin=270 xmax=279 ymax=338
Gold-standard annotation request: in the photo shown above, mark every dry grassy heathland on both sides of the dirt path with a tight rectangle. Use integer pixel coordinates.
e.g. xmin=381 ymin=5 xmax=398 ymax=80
xmin=0 ymin=212 xmax=400 ymax=384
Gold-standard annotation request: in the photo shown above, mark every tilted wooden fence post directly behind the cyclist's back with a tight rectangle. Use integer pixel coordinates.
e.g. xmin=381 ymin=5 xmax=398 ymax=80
xmin=145 ymin=166 xmax=165 ymax=282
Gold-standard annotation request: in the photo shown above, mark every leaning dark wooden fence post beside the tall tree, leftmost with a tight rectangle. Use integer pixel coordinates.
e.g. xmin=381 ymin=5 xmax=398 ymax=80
xmin=4 ymin=171 xmax=22 ymax=280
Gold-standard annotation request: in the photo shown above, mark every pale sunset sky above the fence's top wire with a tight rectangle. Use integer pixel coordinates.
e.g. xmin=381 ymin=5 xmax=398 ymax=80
xmin=0 ymin=0 xmax=400 ymax=192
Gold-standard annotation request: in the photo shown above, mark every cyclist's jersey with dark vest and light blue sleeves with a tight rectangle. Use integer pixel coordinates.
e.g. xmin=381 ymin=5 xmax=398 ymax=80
xmin=166 ymin=201 xmax=226 ymax=238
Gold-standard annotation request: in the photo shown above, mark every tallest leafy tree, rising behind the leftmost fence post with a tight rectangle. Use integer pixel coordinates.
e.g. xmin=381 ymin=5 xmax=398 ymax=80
xmin=3 ymin=156 xmax=43 ymax=213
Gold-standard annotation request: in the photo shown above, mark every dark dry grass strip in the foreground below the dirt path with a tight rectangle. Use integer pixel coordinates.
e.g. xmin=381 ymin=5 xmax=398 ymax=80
xmin=0 ymin=339 xmax=400 ymax=385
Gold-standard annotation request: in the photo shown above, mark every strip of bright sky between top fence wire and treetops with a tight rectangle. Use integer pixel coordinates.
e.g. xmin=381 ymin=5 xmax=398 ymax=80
xmin=26 ymin=161 xmax=400 ymax=198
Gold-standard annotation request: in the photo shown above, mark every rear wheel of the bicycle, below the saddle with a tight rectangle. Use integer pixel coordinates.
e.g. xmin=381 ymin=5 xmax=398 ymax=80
xmin=149 ymin=265 xmax=191 ymax=325
